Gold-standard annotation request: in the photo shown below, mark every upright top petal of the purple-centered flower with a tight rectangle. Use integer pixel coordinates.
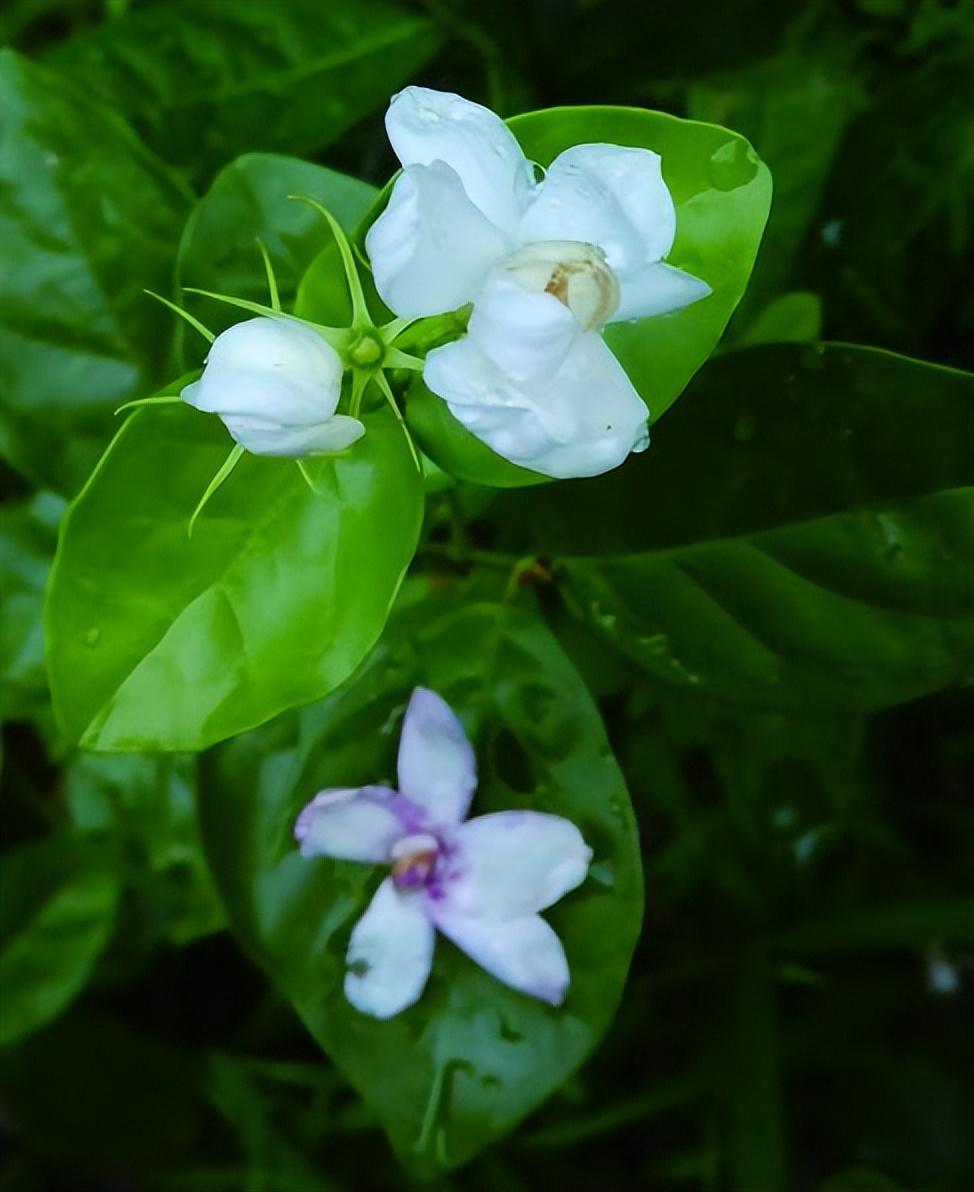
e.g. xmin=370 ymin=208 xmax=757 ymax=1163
xmin=399 ymin=687 xmax=477 ymax=826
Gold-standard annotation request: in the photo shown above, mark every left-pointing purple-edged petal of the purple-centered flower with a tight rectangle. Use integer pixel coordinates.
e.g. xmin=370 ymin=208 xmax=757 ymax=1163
xmin=294 ymin=787 xmax=409 ymax=863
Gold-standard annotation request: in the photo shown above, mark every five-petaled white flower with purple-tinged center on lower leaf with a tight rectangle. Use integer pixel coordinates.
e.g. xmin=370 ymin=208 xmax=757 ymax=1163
xmin=294 ymin=688 xmax=591 ymax=1018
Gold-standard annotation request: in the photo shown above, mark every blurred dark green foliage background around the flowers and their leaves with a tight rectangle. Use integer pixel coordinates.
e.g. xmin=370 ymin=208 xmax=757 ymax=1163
xmin=0 ymin=0 xmax=974 ymax=1192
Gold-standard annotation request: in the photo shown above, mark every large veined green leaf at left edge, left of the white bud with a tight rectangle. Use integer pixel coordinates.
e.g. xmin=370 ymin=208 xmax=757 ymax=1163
xmin=0 ymin=50 xmax=188 ymax=493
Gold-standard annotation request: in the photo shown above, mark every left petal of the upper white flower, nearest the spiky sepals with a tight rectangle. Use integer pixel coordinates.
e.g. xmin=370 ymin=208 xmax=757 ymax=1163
xmin=365 ymin=161 xmax=509 ymax=318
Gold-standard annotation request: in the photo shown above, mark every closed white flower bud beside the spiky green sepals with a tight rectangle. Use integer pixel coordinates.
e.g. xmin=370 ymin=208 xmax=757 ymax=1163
xmin=180 ymin=317 xmax=365 ymax=457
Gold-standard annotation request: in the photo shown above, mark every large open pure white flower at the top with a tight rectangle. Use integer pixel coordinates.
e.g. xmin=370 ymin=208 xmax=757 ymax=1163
xmin=366 ymin=87 xmax=711 ymax=477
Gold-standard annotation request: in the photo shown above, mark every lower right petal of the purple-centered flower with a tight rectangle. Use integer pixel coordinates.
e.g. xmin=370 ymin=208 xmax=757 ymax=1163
xmin=430 ymin=904 xmax=569 ymax=1006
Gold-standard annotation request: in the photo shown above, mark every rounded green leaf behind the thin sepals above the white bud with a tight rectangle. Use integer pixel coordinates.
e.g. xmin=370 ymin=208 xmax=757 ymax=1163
xmin=176 ymin=154 xmax=376 ymax=345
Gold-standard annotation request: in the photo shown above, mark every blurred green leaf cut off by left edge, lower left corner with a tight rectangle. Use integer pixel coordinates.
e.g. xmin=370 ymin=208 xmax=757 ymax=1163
xmin=0 ymin=838 xmax=118 ymax=1047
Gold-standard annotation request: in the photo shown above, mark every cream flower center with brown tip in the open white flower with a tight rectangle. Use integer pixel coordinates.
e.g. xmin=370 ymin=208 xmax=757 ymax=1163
xmin=504 ymin=240 xmax=619 ymax=330
